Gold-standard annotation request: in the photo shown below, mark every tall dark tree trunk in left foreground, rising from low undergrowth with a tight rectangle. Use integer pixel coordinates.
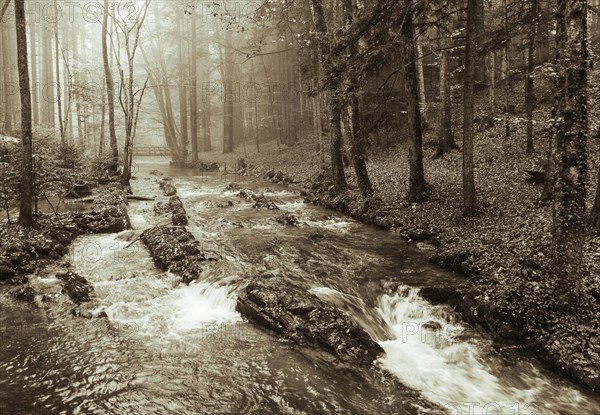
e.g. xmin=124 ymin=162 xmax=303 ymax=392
xmin=15 ymin=0 xmax=34 ymax=227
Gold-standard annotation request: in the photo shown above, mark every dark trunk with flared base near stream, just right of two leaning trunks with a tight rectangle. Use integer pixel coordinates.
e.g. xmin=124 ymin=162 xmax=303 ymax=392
xmin=402 ymin=1 xmax=427 ymax=203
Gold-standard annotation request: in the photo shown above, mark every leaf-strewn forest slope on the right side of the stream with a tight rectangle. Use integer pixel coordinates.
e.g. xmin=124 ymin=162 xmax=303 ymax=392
xmin=202 ymin=67 xmax=600 ymax=390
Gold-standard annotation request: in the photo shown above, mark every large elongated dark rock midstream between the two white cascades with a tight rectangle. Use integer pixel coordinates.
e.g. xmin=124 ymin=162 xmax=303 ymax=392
xmin=236 ymin=277 xmax=383 ymax=366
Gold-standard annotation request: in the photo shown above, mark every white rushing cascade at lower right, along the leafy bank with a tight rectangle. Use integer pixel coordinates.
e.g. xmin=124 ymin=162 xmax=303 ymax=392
xmin=378 ymin=287 xmax=598 ymax=415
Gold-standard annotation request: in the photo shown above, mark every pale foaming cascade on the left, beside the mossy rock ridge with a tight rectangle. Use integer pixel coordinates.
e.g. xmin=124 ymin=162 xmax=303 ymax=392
xmin=71 ymin=231 xmax=241 ymax=337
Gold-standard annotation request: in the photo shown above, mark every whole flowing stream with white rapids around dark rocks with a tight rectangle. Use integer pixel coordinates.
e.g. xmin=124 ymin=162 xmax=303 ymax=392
xmin=0 ymin=159 xmax=600 ymax=415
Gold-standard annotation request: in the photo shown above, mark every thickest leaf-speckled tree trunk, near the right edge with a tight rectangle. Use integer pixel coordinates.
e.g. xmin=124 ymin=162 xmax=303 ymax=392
xmin=552 ymin=0 xmax=588 ymax=308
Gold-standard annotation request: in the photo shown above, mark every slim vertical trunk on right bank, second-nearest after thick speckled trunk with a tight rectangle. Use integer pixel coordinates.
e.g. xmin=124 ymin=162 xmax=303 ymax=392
xmin=463 ymin=0 xmax=480 ymax=216
